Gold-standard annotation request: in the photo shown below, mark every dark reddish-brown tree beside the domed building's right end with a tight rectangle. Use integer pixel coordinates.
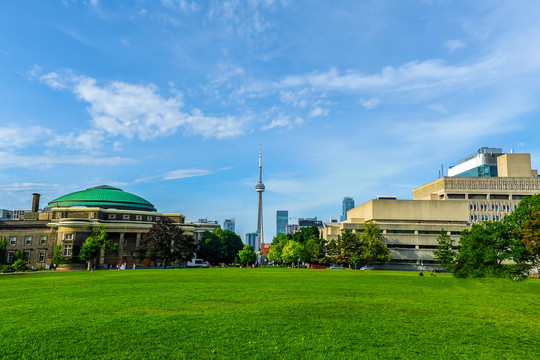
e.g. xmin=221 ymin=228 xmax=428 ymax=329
xmin=139 ymin=217 xmax=197 ymax=265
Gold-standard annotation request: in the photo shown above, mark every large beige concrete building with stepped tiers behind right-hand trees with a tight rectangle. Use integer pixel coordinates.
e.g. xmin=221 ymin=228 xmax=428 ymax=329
xmin=320 ymin=149 xmax=540 ymax=270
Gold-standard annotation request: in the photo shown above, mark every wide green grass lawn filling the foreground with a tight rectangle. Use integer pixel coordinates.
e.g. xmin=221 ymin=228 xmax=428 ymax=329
xmin=0 ymin=268 xmax=540 ymax=359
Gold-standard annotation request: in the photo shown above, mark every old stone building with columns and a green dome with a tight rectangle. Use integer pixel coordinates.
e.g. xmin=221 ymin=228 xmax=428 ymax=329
xmin=0 ymin=185 xmax=195 ymax=268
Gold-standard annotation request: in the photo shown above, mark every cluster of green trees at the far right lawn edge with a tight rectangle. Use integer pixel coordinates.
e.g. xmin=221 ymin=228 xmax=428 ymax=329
xmin=433 ymin=194 xmax=540 ymax=279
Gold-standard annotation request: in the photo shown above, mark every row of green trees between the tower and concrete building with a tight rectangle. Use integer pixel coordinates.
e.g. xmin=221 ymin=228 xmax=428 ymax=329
xmin=267 ymin=222 xmax=391 ymax=268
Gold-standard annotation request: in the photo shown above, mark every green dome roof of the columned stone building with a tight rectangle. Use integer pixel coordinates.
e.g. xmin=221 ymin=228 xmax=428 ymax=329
xmin=45 ymin=185 xmax=156 ymax=211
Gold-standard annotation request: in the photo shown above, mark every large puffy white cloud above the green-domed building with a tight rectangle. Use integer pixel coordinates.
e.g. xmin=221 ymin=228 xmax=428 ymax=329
xmin=40 ymin=71 xmax=245 ymax=141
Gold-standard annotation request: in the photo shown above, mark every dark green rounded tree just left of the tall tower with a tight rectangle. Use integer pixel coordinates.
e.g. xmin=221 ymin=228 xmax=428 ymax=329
xmin=197 ymin=229 xmax=244 ymax=264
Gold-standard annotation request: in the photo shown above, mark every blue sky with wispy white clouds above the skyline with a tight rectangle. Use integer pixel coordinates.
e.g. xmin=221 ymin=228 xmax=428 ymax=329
xmin=0 ymin=0 xmax=540 ymax=241
